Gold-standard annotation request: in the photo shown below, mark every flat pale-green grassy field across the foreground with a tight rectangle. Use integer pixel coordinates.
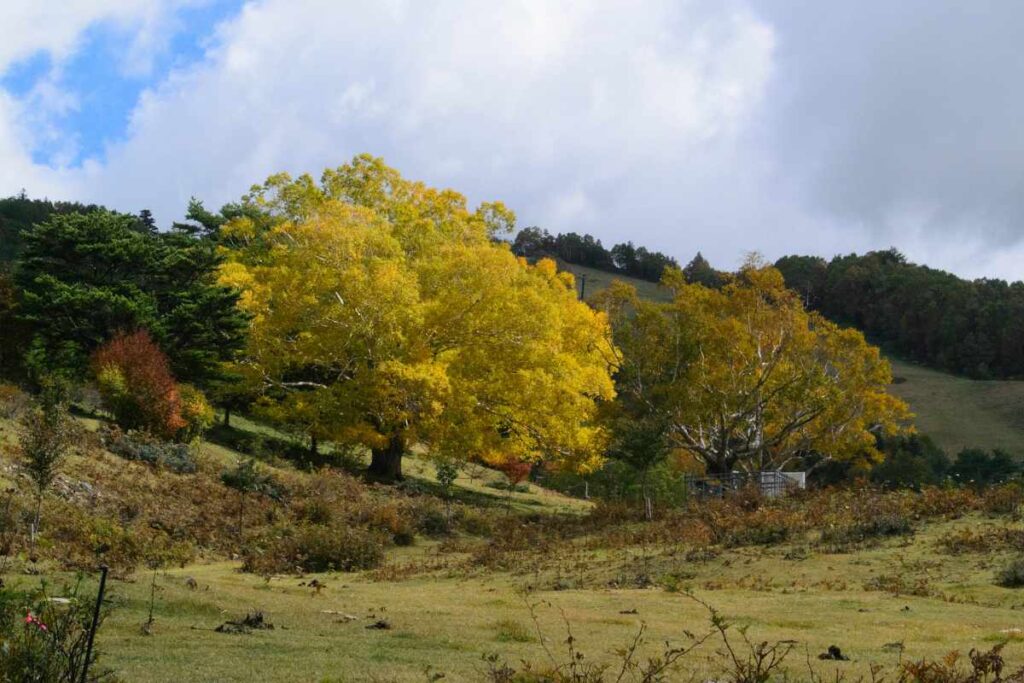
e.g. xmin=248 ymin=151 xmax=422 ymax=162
xmin=25 ymin=509 xmax=1024 ymax=681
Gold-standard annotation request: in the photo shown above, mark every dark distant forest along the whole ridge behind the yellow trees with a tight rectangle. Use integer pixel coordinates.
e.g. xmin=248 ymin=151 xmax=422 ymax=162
xmin=6 ymin=194 xmax=1024 ymax=379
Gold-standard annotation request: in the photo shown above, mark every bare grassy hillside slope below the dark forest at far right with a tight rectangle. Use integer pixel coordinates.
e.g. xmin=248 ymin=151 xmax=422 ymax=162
xmin=890 ymin=358 xmax=1024 ymax=457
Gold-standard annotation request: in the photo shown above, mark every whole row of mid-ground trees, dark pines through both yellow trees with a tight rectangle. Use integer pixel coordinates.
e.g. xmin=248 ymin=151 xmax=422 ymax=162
xmin=0 ymin=156 xmax=907 ymax=499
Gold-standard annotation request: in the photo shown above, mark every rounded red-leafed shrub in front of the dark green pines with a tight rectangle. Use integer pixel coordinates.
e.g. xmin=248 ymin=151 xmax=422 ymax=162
xmin=92 ymin=330 xmax=186 ymax=439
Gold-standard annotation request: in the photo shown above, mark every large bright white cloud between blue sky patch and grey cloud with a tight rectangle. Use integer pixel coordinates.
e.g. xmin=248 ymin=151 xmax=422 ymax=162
xmin=66 ymin=0 xmax=775 ymax=252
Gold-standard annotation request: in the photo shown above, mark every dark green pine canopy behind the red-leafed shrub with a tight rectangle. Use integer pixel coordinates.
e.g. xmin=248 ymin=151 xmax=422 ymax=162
xmin=15 ymin=210 xmax=247 ymax=384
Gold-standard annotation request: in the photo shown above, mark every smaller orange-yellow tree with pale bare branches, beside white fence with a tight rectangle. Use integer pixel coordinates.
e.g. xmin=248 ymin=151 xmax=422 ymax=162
xmin=604 ymin=255 xmax=909 ymax=473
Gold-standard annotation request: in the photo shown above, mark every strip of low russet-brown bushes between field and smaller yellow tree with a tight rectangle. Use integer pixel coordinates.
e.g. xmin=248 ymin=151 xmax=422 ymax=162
xmin=462 ymin=484 xmax=1007 ymax=569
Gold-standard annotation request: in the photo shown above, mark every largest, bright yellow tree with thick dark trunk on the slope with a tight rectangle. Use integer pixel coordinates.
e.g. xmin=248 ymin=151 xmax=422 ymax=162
xmin=222 ymin=156 xmax=613 ymax=479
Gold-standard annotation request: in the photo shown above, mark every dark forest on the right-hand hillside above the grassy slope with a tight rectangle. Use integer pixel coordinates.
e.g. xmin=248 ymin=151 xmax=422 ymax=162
xmin=775 ymin=249 xmax=1024 ymax=379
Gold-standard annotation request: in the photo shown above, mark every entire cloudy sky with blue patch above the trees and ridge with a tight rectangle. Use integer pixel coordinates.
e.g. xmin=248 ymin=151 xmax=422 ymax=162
xmin=0 ymin=0 xmax=1024 ymax=280
